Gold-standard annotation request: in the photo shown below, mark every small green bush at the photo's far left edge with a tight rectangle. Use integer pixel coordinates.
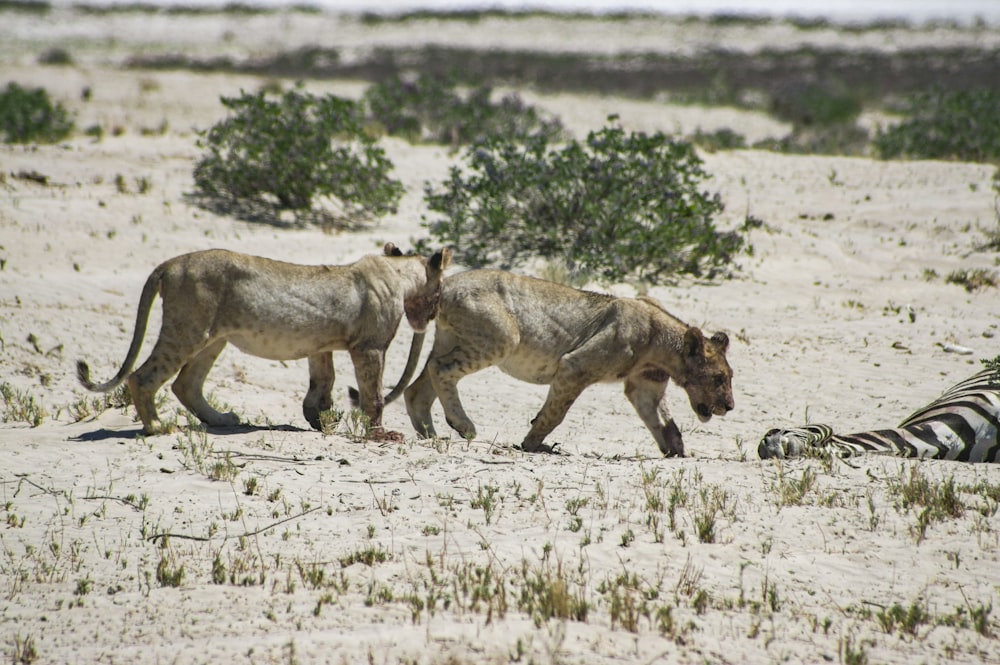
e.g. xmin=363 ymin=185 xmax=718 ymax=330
xmin=0 ymin=83 xmax=73 ymax=143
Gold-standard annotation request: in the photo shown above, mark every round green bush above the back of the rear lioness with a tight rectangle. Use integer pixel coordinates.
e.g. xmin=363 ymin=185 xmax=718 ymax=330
xmin=194 ymin=90 xmax=403 ymax=222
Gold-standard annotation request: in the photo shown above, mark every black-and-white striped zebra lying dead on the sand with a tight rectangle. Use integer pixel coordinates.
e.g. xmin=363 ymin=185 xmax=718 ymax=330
xmin=757 ymin=368 xmax=1000 ymax=463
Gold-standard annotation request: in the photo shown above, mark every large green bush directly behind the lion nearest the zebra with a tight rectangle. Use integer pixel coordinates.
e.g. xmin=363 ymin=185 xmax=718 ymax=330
xmin=425 ymin=116 xmax=749 ymax=283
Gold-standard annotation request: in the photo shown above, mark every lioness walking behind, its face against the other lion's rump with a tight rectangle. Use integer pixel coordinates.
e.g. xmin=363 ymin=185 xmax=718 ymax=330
xmin=77 ymin=243 xmax=451 ymax=434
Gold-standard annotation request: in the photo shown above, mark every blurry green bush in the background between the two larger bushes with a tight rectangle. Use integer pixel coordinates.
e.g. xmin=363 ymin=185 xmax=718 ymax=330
xmin=364 ymin=75 xmax=564 ymax=145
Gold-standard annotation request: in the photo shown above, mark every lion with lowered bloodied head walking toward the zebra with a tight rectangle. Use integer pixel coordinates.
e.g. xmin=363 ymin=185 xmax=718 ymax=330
xmin=405 ymin=270 xmax=733 ymax=456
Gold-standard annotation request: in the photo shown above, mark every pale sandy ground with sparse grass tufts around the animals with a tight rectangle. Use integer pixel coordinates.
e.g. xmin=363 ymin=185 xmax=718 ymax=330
xmin=0 ymin=6 xmax=1000 ymax=664
